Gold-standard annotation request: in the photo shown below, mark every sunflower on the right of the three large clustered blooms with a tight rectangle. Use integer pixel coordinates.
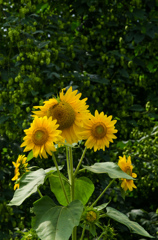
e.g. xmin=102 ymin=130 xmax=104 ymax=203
xmin=81 ymin=110 xmax=117 ymax=152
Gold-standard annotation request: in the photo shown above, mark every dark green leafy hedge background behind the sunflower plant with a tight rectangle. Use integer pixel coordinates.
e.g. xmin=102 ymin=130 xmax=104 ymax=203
xmin=0 ymin=0 xmax=158 ymax=240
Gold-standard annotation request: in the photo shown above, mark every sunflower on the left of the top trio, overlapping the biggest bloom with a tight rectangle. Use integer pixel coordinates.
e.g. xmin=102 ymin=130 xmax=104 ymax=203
xmin=21 ymin=116 xmax=63 ymax=158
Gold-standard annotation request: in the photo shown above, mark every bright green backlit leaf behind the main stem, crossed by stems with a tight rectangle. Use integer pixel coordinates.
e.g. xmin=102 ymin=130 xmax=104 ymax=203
xmin=49 ymin=173 xmax=94 ymax=206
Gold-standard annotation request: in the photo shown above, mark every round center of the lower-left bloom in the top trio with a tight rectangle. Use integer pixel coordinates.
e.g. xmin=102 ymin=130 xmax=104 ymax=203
xmin=32 ymin=128 xmax=48 ymax=145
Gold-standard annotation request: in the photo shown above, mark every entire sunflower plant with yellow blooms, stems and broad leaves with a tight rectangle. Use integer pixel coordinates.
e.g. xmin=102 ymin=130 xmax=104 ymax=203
xmin=9 ymin=87 xmax=153 ymax=240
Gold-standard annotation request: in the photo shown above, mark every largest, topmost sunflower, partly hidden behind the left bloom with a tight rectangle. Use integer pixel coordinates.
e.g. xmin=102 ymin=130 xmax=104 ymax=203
xmin=33 ymin=87 xmax=91 ymax=144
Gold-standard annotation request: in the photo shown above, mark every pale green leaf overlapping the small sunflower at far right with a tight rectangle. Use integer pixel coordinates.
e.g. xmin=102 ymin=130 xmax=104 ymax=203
xmin=83 ymin=162 xmax=133 ymax=180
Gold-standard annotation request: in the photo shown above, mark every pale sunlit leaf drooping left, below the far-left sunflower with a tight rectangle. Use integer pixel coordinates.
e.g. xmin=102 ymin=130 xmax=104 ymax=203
xmin=9 ymin=168 xmax=46 ymax=206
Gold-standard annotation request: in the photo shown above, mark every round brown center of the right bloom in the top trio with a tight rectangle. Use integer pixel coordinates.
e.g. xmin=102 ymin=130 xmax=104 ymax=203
xmin=91 ymin=122 xmax=107 ymax=139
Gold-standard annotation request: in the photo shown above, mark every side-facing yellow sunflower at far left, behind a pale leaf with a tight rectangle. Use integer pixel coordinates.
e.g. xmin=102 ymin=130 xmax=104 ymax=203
xmin=12 ymin=155 xmax=29 ymax=190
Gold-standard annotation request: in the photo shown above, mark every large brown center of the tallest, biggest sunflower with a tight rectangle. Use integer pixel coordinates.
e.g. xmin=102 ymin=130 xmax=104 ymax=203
xmin=47 ymin=101 xmax=75 ymax=130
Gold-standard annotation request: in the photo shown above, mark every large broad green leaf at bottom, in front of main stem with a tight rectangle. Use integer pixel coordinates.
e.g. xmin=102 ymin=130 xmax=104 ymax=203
xmin=33 ymin=196 xmax=83 ymax=240
